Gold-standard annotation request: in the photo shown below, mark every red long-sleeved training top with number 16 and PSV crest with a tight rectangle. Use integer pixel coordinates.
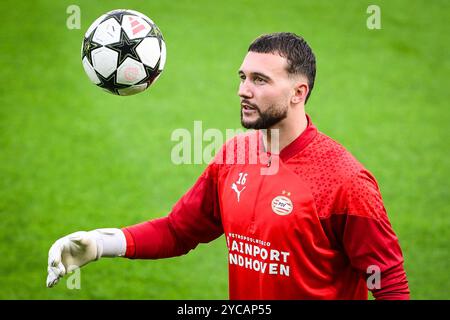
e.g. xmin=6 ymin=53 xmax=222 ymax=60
xmin=123 ymin=117 xmax=409 ymax=299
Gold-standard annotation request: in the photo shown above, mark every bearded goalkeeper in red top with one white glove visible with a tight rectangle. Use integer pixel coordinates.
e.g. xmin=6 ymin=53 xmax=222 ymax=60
xmin=47 ymin=33 xmax=409 ymax=300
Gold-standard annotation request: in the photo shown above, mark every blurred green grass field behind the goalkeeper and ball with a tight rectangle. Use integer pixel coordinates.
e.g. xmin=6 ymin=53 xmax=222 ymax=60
xmin=0 ymin=0 xmax=450 ymax=299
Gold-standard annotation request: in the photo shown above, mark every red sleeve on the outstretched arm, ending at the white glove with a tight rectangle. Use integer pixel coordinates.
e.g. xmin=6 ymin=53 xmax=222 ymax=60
xmin=123 ymin=164 xmax=223 ymax=259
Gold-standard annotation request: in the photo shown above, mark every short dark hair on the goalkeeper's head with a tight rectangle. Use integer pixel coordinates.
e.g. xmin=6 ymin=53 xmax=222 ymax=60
xmin=248 ymin=32 xmax=316 ymax=103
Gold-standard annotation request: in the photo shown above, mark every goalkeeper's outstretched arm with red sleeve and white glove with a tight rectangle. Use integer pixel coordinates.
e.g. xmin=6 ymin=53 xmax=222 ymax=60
xmin=47 ymin=149 xmax=223 ymax=287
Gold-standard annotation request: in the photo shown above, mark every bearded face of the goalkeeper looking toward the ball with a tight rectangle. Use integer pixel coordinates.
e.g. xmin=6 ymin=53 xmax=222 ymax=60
xmin=238 ymin=52 xmax=294 ymax=129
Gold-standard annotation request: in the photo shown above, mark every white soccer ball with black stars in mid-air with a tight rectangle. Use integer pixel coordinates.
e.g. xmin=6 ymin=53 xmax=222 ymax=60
xmin=81 ymin=9 xmax=166 ymax=96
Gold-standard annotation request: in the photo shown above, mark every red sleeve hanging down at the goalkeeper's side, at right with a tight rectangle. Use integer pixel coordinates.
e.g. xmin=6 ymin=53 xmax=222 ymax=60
xmin=341 ymin=171 xmax=409 ymax=300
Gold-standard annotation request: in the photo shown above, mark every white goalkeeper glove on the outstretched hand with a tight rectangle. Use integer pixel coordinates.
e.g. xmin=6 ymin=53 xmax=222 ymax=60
xmin=47 ymin=228 xmax=127 ymax=288
